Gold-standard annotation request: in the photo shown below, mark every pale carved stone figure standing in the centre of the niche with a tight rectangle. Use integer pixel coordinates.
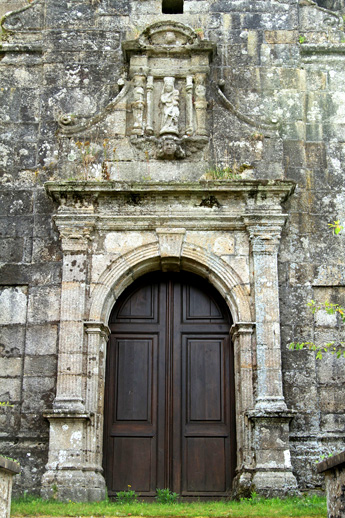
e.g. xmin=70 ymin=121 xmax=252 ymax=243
xmin=160 ymin=77 xmax=180 ymax=135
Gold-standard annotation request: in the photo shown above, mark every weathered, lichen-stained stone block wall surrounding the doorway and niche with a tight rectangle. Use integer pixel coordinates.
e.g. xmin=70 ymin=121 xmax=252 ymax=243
xmin=0 ymin=0 xmax=345 ymax=498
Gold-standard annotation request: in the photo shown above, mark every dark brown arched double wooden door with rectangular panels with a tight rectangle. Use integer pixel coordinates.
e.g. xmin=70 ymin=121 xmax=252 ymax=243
xmin=104 ymin=272 xmax=235 ymax=498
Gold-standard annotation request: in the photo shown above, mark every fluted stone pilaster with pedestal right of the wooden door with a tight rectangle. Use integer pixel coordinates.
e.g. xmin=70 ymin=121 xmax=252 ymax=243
xmin=244 ymin=211 xmax=297 ymax=496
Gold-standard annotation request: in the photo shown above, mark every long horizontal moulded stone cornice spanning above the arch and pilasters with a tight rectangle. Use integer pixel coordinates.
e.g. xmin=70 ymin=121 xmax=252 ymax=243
xmin=45 ymin=180 xmax=295 ymax=234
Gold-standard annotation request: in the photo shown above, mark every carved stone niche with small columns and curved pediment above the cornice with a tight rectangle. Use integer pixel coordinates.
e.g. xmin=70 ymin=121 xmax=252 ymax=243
xmin=123 ymin=22 xmax=215 ymax=159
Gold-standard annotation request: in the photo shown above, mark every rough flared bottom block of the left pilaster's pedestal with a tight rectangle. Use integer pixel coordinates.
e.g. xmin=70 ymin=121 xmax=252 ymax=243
xmin=41 ymin=469 xmax=107 ymax=502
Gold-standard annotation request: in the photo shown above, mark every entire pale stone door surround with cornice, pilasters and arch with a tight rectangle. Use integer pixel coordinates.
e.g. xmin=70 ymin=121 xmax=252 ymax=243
xmin=43 ymin=181 xmax=296 ymax=500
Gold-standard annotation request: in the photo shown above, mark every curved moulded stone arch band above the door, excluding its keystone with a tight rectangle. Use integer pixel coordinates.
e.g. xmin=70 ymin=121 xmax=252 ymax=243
xmin=89 ymin=242 xmax=253 ymax=325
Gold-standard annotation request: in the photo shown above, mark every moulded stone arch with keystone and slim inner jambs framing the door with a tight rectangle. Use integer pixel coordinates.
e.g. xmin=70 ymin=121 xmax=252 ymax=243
xmin=85 ymin=244 xmax=255 ymax=504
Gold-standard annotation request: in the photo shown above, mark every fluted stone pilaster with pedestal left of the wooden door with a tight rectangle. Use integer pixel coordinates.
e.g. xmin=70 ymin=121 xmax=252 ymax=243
xmin=42 ymin=221 xmax=105 ymax=501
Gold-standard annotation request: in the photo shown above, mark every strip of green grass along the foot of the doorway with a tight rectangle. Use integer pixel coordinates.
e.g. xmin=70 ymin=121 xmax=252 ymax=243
xmin=11 ymin=493 xmax=327 ymax=518
